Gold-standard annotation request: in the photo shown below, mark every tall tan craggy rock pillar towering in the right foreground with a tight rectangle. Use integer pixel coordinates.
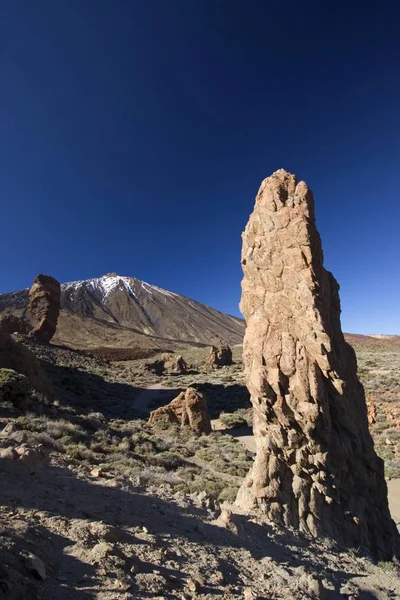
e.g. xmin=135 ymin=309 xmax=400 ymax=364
xmin=237 ymin=170 xmax=399 ymax=558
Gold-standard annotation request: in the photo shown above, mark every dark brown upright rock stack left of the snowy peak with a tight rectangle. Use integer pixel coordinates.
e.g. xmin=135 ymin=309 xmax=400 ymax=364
xmin=28 ymin=275 xmax=61 ymax=342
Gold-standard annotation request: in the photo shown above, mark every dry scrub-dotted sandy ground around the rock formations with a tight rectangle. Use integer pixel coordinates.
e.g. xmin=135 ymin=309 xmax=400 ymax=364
xmin=0 ymin=346 xmax=400 ymax=600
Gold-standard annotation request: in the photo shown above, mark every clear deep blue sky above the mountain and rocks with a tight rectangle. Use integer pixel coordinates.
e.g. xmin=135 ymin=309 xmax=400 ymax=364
xmin=0 ymin=0 xmax=400 ymax=333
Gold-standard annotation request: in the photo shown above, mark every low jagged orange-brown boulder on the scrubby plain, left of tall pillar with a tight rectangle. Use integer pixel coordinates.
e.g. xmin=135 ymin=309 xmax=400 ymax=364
xmin=149 ymin=387 xmax=211 ymax=433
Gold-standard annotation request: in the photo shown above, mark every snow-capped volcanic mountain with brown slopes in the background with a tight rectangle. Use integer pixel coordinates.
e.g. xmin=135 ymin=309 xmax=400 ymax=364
xmin=0 ymin=273 xmax=244 ymax=348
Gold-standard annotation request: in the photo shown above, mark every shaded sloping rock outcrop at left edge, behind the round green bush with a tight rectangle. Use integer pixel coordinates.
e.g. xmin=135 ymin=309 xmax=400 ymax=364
xmin=0 ymin=335 xmax=54 ymax=397
